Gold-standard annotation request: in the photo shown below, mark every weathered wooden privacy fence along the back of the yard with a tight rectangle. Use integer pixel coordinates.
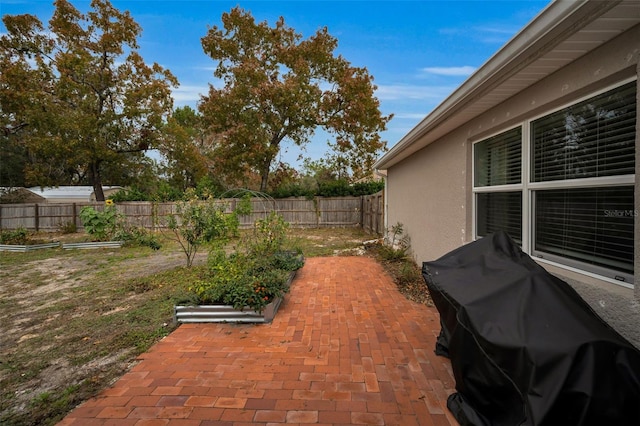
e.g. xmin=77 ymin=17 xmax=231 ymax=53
xmin=0 ymin=192 xmax=384 ymax=234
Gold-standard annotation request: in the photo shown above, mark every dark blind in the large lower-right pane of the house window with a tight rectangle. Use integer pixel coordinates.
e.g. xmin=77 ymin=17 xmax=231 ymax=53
xmin=534 ymin=186 xmax=637 ymax=274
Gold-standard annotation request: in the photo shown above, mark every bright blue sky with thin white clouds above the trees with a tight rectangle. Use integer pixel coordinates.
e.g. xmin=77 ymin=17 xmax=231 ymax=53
xmin=0 ymin=0 xmax=550 ymax=165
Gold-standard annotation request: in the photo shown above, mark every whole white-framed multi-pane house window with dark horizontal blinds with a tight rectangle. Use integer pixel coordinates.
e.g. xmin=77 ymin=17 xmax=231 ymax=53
xmin=473 ymin=80 xmax=637 ymax=281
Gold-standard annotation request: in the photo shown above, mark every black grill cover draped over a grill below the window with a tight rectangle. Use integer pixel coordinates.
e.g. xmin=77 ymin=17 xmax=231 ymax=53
xmin=422 ymin=232 xmax=640 ymax=426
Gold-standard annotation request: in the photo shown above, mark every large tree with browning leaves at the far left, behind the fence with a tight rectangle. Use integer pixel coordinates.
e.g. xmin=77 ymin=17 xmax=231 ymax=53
xmin=0 ymin=0 xmax=177 ymax=200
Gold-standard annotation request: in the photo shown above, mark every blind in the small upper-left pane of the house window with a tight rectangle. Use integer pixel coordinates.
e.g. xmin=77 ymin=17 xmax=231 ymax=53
xmin=473 ymin=127 xmax=522 ymax=187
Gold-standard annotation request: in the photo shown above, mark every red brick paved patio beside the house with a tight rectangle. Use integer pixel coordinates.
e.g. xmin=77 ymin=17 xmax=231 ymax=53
xmin=58 ymin=257 xmax=458 ymax=426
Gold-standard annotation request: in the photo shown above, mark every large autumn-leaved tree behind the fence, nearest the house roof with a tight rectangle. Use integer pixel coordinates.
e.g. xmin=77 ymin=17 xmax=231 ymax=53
xmin=199 ymin=7 xmax=391 ymax=191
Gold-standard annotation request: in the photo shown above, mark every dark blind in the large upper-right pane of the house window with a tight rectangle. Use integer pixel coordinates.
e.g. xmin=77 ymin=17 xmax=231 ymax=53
xmin=531 ymin=81 xmax=636 ymax=182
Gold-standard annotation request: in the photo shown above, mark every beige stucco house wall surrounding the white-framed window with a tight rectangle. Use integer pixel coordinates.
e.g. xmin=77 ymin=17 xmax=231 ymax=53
xmin=387 ymin=26 xmax=640 ymax=295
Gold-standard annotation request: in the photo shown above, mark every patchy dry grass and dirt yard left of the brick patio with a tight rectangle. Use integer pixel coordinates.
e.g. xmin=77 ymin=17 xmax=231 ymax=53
xmin=0 ymin=241 xmax=200 ymax=425
